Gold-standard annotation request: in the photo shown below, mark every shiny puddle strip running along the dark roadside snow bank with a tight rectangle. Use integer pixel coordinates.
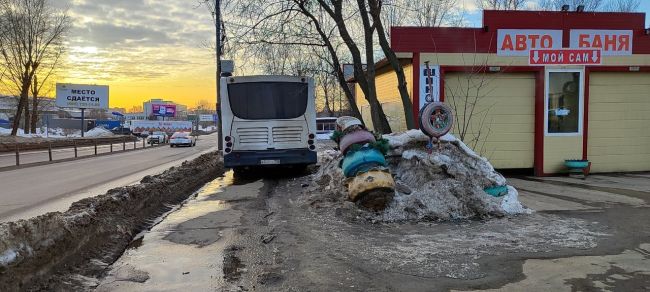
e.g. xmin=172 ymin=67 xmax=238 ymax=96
xmin=96 ymin=171 xmax=264 ymax=291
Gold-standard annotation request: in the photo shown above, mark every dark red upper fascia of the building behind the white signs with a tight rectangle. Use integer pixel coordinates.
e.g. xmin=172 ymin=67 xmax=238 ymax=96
xmin=391 ymin=10 xmax=650 ymax=54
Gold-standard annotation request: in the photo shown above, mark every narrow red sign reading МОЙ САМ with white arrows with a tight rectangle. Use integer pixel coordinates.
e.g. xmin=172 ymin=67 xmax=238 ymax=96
xmin=528 ymin=49 xmax=602 ymax=65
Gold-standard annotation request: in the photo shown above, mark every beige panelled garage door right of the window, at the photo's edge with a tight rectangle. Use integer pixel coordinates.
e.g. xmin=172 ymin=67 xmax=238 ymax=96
xmin=587 ymin=73 xmax=650 ymax=172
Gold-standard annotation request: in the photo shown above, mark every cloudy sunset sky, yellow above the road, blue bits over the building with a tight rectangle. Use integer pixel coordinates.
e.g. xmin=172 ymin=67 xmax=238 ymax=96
xmin=52 ymin=0 xmax=650 ymax=109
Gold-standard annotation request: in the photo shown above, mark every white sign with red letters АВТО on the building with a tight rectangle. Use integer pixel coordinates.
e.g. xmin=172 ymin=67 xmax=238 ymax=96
xmin=497 ymin=29 xmax=562 ymax=56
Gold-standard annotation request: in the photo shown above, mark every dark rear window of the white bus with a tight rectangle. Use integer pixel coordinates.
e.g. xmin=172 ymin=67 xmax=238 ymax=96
xmin=228 ymin=82 xmax=309 ymax=120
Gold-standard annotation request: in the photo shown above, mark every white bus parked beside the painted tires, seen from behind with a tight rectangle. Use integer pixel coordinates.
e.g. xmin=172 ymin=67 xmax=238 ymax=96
xmin=220 ymin=76 xmax=317 ymax=170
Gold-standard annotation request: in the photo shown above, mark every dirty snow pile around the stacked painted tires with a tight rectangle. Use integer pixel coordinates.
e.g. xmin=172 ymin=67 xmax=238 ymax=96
xmin=312 ymin=130 xmax=531 ymax=222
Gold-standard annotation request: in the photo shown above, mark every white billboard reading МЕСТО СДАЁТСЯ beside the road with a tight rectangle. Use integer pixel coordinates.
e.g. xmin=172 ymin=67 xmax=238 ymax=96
xmin=56 ymin=83 xmax=108 ymax=109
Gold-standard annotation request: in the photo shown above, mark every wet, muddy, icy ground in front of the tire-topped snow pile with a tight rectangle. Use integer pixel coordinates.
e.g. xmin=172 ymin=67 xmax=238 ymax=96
xmin=210 ymin=171 xmax=650 ymax=291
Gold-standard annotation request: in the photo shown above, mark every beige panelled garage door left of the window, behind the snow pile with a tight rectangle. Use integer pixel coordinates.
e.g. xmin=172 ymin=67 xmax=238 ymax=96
xmin=445 ymin=73 xmax=535 ymax=169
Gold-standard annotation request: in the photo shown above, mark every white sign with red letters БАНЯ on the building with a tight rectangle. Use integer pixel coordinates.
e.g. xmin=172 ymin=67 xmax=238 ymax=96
xmin=571 ymin=29 xmax=633 ymax=56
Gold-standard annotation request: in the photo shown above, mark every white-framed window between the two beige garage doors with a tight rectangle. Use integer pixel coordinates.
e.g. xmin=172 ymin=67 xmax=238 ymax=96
xmin=546 ymin=70 xmax=584 ymax=136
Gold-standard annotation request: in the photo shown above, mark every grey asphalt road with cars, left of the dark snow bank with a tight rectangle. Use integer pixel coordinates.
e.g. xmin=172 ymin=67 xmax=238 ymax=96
xmin=0 ymin=134 xmax=217 ymax=222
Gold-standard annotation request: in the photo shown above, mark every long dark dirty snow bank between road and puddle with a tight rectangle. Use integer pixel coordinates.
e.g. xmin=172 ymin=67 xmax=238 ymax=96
xmin=0 ymin=152 xmax=223 ymax=291
